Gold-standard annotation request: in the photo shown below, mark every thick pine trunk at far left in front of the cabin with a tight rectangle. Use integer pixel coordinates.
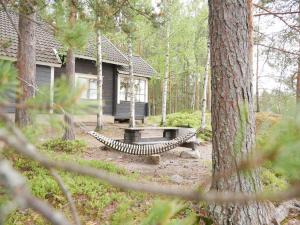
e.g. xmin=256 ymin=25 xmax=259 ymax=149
xmin=15 ymin=0 xmax=36 ymax=127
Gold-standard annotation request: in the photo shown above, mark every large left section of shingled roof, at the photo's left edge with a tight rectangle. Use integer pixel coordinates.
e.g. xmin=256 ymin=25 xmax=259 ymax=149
xmin=0 ymin=10 xmax=61 ymax=67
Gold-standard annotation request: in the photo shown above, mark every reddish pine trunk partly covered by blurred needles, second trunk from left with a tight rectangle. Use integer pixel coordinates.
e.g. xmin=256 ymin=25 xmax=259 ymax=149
xmin=63 ymin=2 xmax=76 ymax=140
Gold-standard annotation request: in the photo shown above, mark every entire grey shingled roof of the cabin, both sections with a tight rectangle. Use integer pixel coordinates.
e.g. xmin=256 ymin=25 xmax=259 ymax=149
xmin=0 ymin=9 xmax=155 ymax=77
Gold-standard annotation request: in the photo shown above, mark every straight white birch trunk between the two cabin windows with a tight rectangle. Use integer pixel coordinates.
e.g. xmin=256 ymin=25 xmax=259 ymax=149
xmin=95 ymin=23 xmax=103 ymax=131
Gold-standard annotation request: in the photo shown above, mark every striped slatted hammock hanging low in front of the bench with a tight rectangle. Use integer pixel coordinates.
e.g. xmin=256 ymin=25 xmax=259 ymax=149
xmin=88 ymin=128 xmax=202 ymax=155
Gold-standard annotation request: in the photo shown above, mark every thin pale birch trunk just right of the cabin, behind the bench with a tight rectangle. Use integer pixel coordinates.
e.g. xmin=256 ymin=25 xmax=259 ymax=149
xmin=161 ymin=22 xmax=170 ymax=126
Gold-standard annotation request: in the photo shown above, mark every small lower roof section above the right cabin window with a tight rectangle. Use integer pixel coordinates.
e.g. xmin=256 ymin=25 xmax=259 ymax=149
xmin=118 ymin=55 xmax=156 ymax=77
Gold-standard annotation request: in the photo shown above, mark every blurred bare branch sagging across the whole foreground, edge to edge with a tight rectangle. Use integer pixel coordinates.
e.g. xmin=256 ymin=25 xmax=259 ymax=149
xmin=0 ymin=113 xmax=300 ymax=203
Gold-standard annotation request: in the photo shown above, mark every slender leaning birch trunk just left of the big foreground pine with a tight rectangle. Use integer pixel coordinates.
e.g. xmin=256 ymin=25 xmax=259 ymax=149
xmin=201 ymin=44 xmax=210 ymax=129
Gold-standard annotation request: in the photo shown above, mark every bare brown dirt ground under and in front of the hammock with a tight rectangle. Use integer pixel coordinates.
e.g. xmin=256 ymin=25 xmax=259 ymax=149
xmin=80 ymin=124 xmax=211 ymax=188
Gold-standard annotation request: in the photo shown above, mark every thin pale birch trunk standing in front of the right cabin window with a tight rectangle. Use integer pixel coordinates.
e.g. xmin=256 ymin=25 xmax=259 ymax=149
xmin=128 ymin=34 xmax=135 ymax=127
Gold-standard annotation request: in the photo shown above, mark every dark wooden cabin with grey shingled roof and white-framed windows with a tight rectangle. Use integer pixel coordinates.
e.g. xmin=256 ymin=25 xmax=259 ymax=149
xmin=0 ymin=10 xmax=155 ymax=120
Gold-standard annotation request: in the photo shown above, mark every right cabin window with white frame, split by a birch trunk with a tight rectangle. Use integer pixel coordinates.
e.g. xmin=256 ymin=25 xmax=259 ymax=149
xmin=118 ymin=77 xmax=147 ymax=102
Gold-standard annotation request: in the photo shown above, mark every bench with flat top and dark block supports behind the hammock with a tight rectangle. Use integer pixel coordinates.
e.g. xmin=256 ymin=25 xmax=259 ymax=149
xmin=124 ymin=127 xmax=199 ymax=150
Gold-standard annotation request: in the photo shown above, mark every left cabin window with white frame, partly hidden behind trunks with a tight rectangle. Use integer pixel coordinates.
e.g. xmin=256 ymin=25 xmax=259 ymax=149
xmin=76 ymin=75 xmax=97 ymax=100
